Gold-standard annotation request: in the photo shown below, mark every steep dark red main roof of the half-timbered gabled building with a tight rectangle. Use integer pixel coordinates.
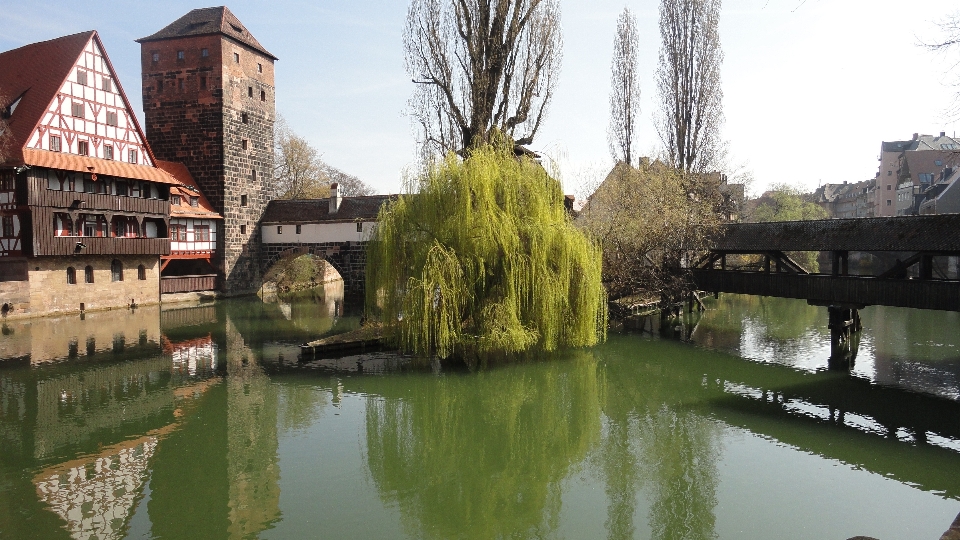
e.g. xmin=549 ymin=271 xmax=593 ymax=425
xmin=0 ymin=30 xmax=159 ymax=170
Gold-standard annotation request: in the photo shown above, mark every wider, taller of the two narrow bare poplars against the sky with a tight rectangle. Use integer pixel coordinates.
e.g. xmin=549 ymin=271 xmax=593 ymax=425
xmin=657 ymin=0 xmax=723 ymax=173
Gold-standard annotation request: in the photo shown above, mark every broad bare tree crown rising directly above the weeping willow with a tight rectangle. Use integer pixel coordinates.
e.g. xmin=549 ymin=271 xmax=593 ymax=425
xmin=403 ymin=0 xmax=562 ymax=153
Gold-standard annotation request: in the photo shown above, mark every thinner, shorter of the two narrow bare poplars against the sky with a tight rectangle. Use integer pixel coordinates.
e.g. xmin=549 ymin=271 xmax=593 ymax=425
xmin=607 ymin=8 xmax=640 ymax=165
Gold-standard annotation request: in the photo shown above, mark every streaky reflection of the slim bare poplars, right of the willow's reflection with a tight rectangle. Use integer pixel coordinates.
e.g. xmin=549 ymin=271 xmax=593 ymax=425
xmin=597 ymin=340 xmax=719 ymax=539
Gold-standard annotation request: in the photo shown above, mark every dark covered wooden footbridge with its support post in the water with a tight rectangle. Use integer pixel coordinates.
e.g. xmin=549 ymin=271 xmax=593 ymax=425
xmin=692 ymin=215 xmax=960 ymax=354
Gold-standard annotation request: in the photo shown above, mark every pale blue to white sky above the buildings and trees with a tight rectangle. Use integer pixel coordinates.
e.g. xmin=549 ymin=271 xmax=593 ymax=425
xmin=0 ymin=0 xmax=960 ymax=194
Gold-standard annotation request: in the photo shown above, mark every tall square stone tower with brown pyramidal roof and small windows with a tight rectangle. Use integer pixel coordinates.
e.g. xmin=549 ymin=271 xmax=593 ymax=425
xmin=137 ymin=7 xmax=277 ymax=293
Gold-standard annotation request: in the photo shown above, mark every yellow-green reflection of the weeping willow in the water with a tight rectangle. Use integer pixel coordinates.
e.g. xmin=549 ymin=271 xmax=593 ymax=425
xmin=366 ymin=357 xmax=599 ymax=538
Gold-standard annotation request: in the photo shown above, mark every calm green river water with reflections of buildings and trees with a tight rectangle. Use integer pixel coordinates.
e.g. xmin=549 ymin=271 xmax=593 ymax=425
xmin=0 ymin=296 xmax=960 ymax=540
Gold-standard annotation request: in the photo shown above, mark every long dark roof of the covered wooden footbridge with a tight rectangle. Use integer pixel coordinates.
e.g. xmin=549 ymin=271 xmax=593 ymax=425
xmin=711 ymin=214 xmax=960 ymax=253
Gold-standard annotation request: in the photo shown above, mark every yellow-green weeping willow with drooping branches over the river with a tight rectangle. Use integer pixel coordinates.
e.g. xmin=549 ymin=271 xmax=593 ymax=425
xmin=366 ymin=144 xmax=607 ymax=359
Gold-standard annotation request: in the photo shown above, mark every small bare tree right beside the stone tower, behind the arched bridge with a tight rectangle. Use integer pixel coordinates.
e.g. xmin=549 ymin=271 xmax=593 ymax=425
xmin=274 ymin=116 xmax=330 ymax=199
